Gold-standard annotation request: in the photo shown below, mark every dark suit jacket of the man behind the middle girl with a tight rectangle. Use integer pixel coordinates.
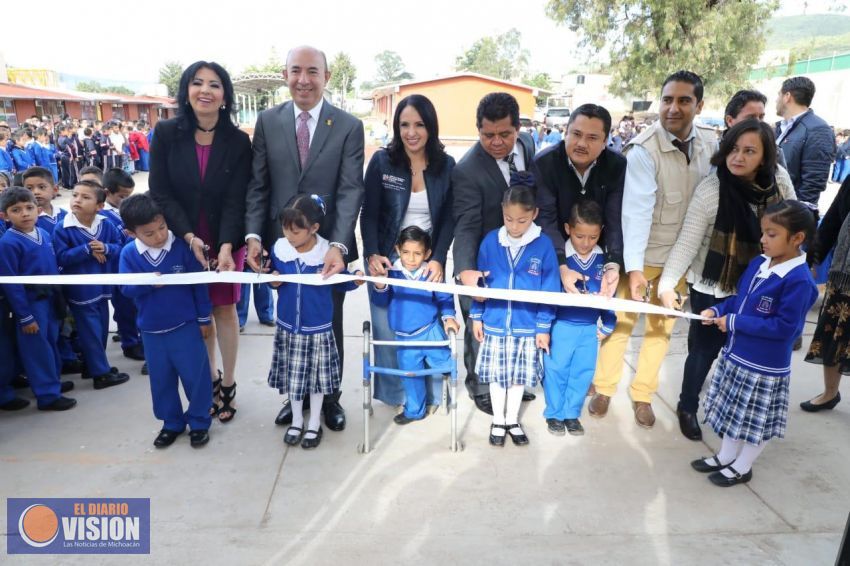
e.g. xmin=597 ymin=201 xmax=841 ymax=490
xmin=452 ymin=132 xmax=534 ymax=274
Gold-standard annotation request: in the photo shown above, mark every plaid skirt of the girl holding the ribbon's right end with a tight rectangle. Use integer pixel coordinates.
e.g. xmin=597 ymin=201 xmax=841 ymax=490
xmin=703 ymin=354 xmax=791 ymax=444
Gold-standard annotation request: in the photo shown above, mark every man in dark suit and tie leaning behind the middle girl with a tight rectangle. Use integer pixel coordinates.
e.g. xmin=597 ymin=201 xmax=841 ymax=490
xmin=452 ymin=92 xmax=534 ymax=415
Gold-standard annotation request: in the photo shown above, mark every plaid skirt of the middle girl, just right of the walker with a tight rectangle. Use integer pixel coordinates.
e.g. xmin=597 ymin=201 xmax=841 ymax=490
xmin=475 ymin=334 xmax=543 ymax=389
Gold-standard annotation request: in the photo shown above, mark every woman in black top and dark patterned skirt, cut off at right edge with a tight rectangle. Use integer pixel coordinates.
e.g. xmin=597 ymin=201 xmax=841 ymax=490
xmin=800 ymin=177 xmax=850 ymax=413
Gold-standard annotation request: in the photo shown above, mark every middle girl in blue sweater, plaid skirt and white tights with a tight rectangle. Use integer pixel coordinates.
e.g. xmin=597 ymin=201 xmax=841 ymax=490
xmin=469 ymin=173 xmax=561 ymax=446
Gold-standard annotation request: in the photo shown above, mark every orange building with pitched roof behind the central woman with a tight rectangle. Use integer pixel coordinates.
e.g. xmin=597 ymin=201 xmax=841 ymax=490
xmin=372 ymin=73 xmax=540 ymax=140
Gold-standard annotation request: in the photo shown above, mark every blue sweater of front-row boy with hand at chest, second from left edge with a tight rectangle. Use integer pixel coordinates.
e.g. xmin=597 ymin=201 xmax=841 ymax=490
xmin=53 ymin=212 xmax=121 ymax=305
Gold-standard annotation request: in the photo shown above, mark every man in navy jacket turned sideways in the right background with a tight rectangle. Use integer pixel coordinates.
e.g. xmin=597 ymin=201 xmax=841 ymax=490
xmin=776 ymin=77 xmax=835 ymax=213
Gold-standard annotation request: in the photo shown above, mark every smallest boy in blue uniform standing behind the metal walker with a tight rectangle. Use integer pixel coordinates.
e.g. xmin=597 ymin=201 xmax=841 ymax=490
xmin=372 ymin=226 xmax=460 ymax=425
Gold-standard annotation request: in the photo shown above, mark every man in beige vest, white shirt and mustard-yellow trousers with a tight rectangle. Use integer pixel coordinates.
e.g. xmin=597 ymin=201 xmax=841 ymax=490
xmin=588 ymin=71 xmax=717 ymax=428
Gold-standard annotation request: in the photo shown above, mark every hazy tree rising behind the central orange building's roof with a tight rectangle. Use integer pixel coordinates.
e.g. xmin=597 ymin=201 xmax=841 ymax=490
xmin=455 ymin=28 xmax=528 ymax=80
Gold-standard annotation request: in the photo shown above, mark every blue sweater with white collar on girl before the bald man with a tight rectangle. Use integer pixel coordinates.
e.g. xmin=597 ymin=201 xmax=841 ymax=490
xmin=272 ymin=236 xmax=357 ymax=334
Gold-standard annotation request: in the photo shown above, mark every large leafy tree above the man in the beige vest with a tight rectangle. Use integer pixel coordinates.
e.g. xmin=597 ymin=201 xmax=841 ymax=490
xmin=546 ymin=0 xmax=779 ymax=96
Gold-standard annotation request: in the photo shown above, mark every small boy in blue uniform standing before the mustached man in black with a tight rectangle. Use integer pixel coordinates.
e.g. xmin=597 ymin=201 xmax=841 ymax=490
xmin=543 ymin=199 xmax=617 ymax=436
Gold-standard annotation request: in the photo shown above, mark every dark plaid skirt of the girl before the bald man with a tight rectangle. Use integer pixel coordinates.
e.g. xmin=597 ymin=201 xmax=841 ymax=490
xmin=269 ymin=326 xmax=341 ymax=401
